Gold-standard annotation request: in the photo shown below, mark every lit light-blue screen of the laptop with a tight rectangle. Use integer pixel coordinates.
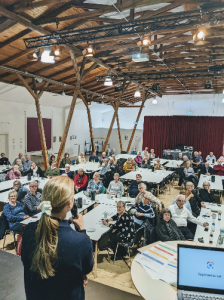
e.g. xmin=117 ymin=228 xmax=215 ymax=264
xmin=178 ymin=248 xmax=224 ymax=290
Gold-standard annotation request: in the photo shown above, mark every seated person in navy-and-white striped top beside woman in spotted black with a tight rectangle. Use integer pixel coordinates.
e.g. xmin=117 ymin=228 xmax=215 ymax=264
xmin=133 ymin=194 xmax=155 ymax=229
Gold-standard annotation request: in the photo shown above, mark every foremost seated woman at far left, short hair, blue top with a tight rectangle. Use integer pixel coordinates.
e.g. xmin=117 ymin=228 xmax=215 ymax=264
xmin=3 ymin=191 xmax=30 ymax=234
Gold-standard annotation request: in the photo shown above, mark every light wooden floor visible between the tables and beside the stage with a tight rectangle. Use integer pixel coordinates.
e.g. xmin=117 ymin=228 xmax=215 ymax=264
xmin=0 ymin=178 xmax=180 ymax=295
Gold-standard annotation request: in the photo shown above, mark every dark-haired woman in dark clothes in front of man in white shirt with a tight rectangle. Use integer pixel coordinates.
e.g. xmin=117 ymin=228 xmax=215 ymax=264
xmin=156 ymin=208 xmax=185 ymax=242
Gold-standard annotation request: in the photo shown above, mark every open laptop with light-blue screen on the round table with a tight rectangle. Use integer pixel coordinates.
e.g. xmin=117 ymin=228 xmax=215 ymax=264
xmin=177 ymin=245 xmax=224 ymax=300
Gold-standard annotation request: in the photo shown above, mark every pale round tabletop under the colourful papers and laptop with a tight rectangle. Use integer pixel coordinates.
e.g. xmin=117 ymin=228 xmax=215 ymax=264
xmin=131 ymin=241 xmax=197 ymax=300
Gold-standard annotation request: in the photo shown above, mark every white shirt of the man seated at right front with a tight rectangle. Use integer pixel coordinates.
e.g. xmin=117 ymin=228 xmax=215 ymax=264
xmin=168 ymin=204 xmax=203 ymax=227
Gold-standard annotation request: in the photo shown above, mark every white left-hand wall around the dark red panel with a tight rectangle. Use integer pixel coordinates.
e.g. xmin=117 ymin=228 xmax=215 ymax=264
xmin=0 ymin=100 xmax=64 ymax=162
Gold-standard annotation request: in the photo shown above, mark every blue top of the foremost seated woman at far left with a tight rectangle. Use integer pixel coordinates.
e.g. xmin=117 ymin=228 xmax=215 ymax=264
xmin=3 ymin=202 xmax=25 ymax=228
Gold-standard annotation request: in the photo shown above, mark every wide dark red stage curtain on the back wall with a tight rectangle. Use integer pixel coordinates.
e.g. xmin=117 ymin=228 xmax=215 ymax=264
xmin=143 ymin=116 xmax=224 ymax=159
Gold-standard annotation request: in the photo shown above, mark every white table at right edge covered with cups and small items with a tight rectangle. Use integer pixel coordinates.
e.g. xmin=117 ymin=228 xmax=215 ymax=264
xmin=194 ymin=203 xmax=224 ymax=247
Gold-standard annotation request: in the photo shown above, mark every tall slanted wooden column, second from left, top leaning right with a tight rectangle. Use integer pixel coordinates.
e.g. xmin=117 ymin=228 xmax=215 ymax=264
xmin=57 ymin=50 xmax=81 ymax=168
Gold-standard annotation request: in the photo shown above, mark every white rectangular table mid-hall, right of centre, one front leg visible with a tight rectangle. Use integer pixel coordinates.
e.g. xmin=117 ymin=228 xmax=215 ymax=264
xmin=120 ymin=168 xmax=174 ymax=197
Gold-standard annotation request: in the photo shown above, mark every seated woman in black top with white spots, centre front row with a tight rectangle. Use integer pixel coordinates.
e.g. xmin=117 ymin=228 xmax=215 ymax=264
xmin=102 ymin=201 xmax=134 ymax=259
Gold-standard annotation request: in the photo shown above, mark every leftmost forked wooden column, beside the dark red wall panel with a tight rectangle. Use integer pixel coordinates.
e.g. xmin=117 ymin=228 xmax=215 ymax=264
xmin=17 ymin=74 xmax=49 ymax=170
